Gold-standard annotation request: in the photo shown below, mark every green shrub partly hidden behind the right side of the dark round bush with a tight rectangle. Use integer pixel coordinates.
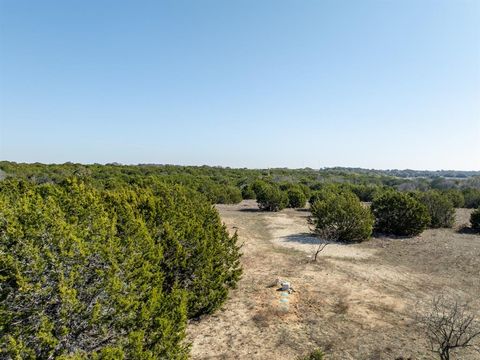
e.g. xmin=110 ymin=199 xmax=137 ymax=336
xmin=414 ymin=191 xmax=455 ymax=228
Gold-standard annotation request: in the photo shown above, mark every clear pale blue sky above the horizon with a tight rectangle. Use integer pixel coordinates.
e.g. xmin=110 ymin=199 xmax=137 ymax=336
xmin=0 ymin=0 xmax=480 ymax=170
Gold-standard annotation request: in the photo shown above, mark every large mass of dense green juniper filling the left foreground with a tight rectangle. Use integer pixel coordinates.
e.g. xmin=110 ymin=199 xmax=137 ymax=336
xmin=0 ymin=181 xmax=240 ymax=359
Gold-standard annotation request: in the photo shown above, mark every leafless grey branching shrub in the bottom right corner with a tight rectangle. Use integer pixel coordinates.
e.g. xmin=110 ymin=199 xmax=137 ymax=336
xmin=419 ymin=295 xmax=480 ymax=360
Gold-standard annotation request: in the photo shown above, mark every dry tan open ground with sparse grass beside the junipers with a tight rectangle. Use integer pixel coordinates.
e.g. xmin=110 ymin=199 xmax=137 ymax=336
xmin=188 ymin=201 xmax=480 ymax=360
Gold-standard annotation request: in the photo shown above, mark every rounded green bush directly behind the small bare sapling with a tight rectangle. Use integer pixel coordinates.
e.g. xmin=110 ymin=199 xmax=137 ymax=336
xmin=311 ymin=192 xmax=374 ymax=242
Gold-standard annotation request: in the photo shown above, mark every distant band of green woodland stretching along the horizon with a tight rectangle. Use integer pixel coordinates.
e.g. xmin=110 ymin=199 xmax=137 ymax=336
xmin=0 ymin=161 xmax=480 ymax=207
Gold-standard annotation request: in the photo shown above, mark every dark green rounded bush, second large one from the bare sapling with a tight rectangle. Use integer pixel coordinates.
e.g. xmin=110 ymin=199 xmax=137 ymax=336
xmin=371 ymin=191 xmax=430 ymax=236
